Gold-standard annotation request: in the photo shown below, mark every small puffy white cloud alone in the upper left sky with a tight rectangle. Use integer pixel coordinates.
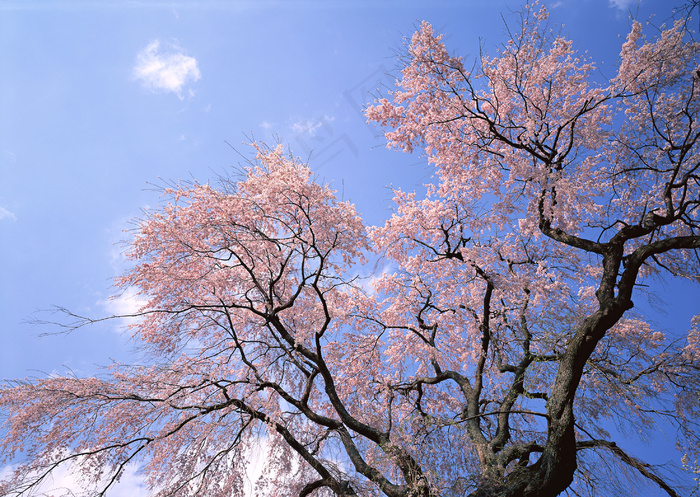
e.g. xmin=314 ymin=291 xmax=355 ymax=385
xmin=134 ymin=40 xmax=202 ymax=100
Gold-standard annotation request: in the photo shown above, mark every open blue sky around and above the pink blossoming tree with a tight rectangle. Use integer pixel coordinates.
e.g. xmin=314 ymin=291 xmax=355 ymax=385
xmin=0 ymin=0 xmax=700 ymax=494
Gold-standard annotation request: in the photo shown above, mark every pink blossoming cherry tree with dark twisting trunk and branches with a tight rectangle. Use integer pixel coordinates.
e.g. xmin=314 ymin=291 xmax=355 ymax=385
xmin=0 ymin=7 xmax=700 ymax=497
